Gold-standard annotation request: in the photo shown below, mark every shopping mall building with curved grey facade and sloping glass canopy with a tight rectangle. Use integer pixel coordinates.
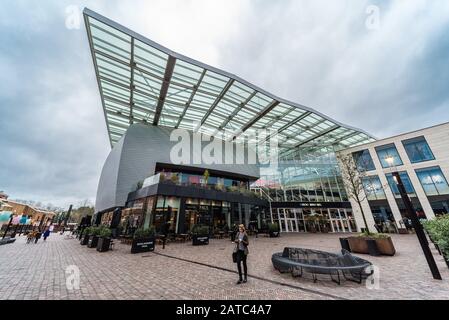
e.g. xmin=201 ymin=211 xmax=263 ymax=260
xmin=84 ymin=9 xmax=448 ymax=233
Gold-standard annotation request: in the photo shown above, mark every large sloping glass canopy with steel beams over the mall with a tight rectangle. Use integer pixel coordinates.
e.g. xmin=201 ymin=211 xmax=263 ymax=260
xmin=84 ymin=8 xmax=374 ymax=154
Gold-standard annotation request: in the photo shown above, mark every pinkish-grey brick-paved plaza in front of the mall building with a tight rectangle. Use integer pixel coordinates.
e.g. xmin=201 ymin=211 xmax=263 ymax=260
xmin=0 ymin=234 xmax=449 ymax=300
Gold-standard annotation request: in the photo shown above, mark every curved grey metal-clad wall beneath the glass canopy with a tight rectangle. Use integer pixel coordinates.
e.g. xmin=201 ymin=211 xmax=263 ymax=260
xmin=95 ymin=124 xmax=259 ymax=212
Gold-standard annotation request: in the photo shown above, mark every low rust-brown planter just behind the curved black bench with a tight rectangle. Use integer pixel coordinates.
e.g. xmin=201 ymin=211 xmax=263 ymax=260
xmin=348 ymin=232 xmax=396 ymax=256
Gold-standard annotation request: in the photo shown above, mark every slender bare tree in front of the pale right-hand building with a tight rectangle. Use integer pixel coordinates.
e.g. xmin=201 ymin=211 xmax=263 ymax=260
xmin=337 ymin=154 xmax=370 ymax=234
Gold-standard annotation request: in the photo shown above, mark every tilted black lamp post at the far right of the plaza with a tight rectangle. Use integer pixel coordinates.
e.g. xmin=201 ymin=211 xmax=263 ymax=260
xmin=386 ymin=157 xmax=442 ymax=280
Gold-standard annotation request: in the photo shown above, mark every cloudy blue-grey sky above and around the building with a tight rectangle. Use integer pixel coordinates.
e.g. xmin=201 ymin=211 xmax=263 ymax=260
xmin=0 ymin=0 xmax=449 ymax=207
